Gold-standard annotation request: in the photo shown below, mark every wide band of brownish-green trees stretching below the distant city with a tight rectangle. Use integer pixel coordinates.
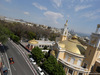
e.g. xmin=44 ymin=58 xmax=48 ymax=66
xmin=0 ymin=20 xmax=59 ymax=41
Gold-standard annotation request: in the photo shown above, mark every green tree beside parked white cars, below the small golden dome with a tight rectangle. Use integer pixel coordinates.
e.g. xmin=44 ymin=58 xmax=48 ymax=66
xmin=32 ymin=47 xmax=44 ymax=64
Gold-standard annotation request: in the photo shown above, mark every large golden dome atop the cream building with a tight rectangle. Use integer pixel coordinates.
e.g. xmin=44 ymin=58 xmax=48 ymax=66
xmin=59 ymin=39 xmax=85 ymax=55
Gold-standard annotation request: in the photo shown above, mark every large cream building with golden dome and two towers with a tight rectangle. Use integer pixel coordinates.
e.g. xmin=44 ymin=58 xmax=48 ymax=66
xmin=51 ymin=21 xmax=100 ymax=75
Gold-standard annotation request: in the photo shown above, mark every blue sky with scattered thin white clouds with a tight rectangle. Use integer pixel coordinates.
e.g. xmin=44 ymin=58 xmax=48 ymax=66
xmin=0 ymin=0 xmax=100 ymax=34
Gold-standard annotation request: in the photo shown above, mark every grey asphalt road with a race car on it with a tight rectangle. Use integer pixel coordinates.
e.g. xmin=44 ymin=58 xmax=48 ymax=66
xmin=5 ymin=41 xmax=33 ymax=75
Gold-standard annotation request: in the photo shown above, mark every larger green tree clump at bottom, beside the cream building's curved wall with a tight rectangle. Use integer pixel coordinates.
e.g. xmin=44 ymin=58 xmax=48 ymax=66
xmin=42 ymin=56 xmax=65 ymax=75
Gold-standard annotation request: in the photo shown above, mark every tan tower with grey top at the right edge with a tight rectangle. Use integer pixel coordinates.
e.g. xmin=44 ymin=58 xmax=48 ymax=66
xmin=82 ymin=24 xmax=100 ymax=71
